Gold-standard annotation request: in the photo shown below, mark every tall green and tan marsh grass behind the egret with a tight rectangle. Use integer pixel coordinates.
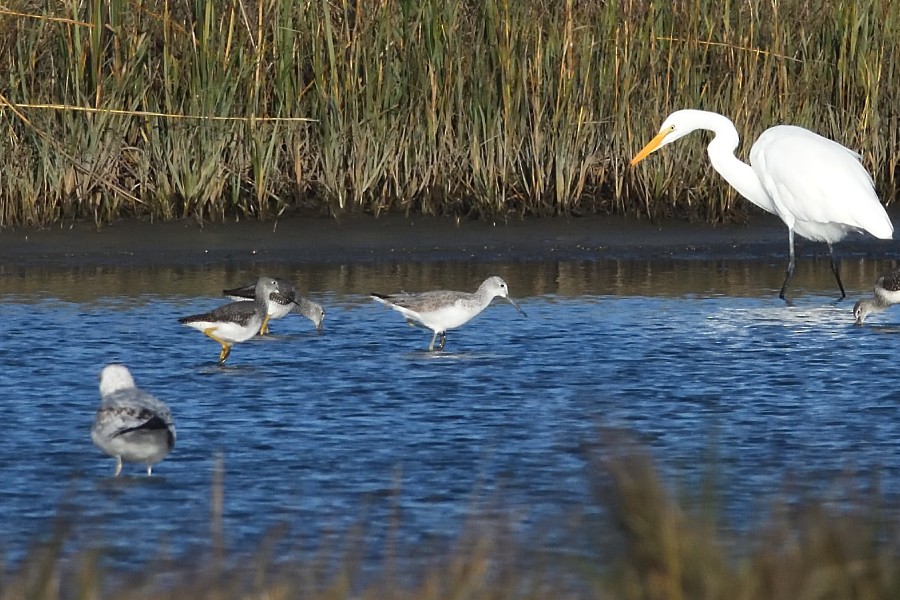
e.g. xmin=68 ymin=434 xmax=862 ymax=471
xmin=0 ymin=0 xmax=900 ymax=227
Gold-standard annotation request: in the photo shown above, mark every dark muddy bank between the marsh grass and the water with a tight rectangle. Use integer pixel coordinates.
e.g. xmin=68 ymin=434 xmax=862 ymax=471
xmin=0 ymin=214 xmax=900 ymax=268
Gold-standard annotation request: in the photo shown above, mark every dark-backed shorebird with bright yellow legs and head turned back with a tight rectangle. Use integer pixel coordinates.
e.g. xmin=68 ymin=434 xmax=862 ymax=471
xmin=178 ymin=276 xmax=280 ymax=363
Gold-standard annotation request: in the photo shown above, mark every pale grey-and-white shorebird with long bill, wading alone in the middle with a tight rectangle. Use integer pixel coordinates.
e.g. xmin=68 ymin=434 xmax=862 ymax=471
xmin=372 ymin=276 xmax=525 ymax=352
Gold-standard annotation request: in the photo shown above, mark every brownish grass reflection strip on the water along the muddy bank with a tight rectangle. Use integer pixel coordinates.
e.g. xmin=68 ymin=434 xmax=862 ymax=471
xmin=0 ymin=257 xmax=895 ymax=303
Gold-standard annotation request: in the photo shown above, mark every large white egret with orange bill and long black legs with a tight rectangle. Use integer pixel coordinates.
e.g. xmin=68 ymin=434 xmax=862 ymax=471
xmin=631 ymin=110 xmax=894 ymax=299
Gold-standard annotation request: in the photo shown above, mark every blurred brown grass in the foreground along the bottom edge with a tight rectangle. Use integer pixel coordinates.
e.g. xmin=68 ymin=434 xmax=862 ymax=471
xmin=0 ymin=438 xmax=900 ymax=600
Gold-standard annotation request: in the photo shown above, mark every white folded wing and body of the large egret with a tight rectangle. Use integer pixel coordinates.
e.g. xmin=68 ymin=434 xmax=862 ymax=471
xmin=750 ymin=125 xmax=894 ymax=239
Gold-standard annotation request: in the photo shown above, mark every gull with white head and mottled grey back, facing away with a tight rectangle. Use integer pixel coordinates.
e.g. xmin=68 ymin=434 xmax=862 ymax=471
xmin=91 ymin=364 xmax=175 ymax=477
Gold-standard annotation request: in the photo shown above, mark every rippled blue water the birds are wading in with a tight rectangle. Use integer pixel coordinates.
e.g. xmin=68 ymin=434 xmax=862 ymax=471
xmin=0 ymin=261 xmax=900 ymax=567
